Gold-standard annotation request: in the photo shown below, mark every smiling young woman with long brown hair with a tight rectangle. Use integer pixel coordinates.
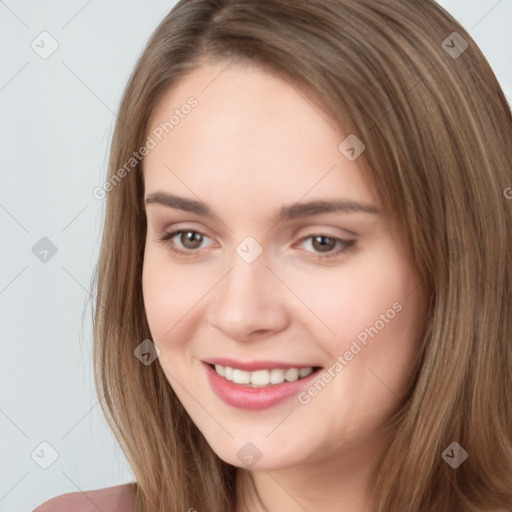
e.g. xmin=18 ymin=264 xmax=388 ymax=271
xmin=37 ymin=0 xmax=512 ymax=512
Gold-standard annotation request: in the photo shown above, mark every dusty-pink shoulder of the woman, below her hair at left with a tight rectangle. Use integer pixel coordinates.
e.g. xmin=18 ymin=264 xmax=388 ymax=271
xmin=33 ymin=484 xmax=136 ymax=512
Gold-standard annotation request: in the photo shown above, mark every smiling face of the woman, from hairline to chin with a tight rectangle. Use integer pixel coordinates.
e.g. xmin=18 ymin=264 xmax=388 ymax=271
xmin=142 ymin=63 xmax=427 ymax=469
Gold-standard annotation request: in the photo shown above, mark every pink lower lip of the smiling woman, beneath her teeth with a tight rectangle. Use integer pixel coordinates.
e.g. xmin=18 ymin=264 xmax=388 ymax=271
xmin=203 ymin=363 xmax=319 ymax=411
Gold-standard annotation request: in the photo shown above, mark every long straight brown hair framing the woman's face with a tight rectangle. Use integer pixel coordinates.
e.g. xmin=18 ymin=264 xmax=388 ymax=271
xmin=93 ymin=0 xmax=512 ymax=512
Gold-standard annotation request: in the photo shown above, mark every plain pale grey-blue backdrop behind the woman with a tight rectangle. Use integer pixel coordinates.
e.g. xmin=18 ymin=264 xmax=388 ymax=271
xmin=0 ymin=0 xmax=512 ymax=512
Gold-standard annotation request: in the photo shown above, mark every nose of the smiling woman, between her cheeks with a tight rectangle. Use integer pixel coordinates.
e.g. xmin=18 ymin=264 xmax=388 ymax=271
xmin=208 ymin=247 xmax=290 ymax=341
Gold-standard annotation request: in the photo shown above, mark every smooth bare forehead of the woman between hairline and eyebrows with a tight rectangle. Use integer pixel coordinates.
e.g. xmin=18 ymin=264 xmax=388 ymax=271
xmin=143 ymin=62 xmax=378 ymax=216
